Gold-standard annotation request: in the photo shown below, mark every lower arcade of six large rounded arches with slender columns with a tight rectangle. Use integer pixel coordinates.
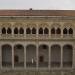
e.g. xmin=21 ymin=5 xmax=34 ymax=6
xmin=1 ymin=44 xmax=73 ymax=69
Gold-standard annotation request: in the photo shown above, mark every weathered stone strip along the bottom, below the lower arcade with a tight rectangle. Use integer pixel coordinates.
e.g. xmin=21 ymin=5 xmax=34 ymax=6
xmin=0 ymin=70 xmax=75 ymax=75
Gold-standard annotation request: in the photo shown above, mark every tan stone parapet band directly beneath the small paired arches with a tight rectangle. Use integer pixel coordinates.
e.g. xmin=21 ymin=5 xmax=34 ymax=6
xmin=0 ymin=34 xmax=74 ymax=40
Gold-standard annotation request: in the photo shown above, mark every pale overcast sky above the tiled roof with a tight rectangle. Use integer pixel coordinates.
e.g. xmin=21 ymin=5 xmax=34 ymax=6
xmin=0 ymin=0 xmax=75 ymax=10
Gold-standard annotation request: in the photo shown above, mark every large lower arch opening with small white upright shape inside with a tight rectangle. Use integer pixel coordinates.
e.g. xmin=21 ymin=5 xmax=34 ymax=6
xmin=26 ymin=44 xmax=36 ymax=67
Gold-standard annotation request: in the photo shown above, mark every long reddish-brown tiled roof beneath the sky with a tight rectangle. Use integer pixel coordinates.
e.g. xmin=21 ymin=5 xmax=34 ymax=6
xmin=0 ymin=9 xmax=75 ymax=16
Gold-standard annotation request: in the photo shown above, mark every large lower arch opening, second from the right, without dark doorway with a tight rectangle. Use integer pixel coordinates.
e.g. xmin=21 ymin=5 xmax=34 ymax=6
xmin=51 ymin=44 xmax=61 ymax=67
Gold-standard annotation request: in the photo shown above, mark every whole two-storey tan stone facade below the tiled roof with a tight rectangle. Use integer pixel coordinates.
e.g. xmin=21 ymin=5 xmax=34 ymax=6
xmin=0 ymin=10 xmax=75 ymax=75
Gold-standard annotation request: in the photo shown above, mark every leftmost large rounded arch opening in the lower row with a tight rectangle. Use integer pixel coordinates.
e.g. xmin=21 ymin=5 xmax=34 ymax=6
xmin=1 ymin=44 xmax=12 ymax=67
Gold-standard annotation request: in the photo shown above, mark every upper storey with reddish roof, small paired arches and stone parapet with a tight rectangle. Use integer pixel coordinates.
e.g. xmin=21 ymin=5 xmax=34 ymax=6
xmin=0 ymin=10 xmax=75 ymax=40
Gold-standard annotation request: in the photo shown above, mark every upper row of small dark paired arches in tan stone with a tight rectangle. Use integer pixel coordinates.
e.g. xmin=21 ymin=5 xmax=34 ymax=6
xmin=1 ymin=23 xmax=74 ymax=36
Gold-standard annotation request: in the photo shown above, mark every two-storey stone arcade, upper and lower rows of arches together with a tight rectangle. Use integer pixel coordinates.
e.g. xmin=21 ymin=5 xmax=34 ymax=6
xmin=0 ymin=23 xmax=75 ymax=69
